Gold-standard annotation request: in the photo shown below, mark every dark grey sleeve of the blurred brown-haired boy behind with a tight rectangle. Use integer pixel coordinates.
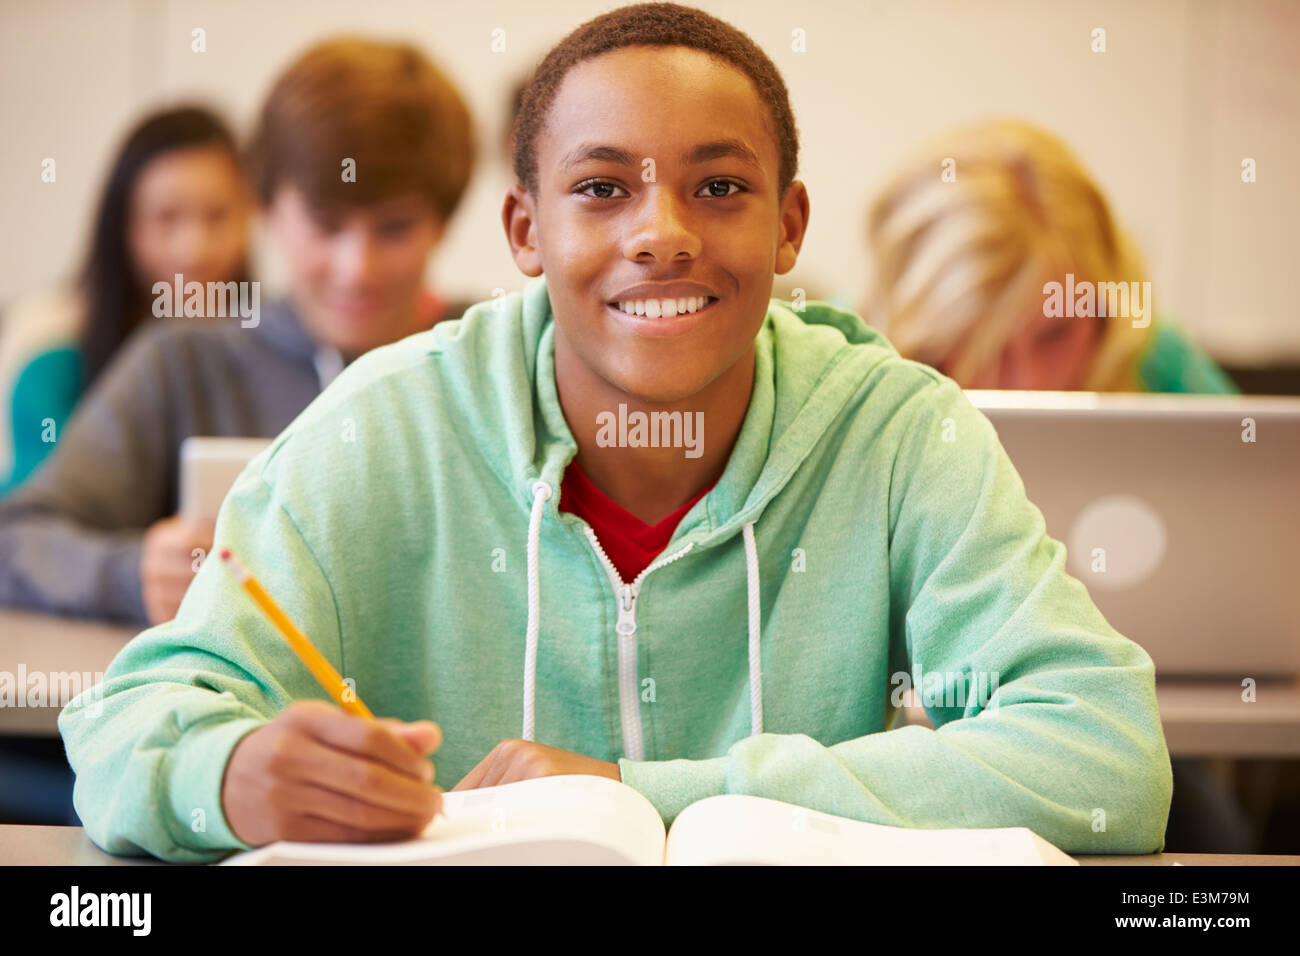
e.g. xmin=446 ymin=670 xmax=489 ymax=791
xmin=0 ymin=329 xmax=177 ymax=623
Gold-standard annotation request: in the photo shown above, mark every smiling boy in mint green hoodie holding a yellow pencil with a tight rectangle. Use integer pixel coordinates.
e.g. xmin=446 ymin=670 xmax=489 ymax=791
xmin=60 ymin=4 xmax=1170 ymax=861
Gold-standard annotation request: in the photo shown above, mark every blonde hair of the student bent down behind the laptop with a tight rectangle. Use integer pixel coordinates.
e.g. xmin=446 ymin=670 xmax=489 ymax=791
xmin=865 ymin=120 xmax=1152 ymax=392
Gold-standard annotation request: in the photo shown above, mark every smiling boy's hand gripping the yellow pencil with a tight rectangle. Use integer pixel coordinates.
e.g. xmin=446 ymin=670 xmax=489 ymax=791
xmin=221 ymin=701 xmax=442 ymax=847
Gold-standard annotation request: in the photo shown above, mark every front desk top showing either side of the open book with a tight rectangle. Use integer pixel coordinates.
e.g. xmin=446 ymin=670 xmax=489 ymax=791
xmin=0 ymin=826 xmax=1300 ymax=866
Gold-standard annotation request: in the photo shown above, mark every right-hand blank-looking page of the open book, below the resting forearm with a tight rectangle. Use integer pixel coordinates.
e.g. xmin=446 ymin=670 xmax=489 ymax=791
xmin=664 ymin=795 xmax=1078 ymax=866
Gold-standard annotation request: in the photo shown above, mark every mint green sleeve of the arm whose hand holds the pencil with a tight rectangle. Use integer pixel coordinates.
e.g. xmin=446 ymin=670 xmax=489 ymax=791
xmin=59 ymin=467 xmax=347 ymax=862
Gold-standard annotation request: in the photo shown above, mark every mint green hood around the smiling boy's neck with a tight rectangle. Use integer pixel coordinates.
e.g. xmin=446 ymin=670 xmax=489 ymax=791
xmin=429 ymin=276 xmax=894 ymax=548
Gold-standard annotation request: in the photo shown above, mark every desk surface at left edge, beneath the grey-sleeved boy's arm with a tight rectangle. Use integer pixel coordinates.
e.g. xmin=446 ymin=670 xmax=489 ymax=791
xmin=0 ymin=609 xmax=137 ymax=736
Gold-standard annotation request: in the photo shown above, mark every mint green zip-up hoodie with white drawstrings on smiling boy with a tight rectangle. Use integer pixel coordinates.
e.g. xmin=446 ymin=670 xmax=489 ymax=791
xmin=60 ymin=277 xmax=1171 ymax=861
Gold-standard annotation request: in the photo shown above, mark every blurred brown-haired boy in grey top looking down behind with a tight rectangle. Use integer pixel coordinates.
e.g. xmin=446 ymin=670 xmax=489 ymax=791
xmin=0 ymin=39 xmax=475 ymax=623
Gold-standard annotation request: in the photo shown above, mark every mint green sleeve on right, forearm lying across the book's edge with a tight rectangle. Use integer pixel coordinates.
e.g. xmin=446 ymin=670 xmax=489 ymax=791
xmin=619 ymin=378 xmax=1173 ymax=853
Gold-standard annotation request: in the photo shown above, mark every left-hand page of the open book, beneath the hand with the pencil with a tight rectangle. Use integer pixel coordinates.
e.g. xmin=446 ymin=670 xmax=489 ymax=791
xmin=222 ymin=774 xmax=664 ymax=866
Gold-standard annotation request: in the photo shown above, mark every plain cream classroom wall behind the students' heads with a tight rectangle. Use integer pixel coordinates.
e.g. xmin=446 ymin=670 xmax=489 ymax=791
xmin=0 ymin=0 xmax=1300 ymax=362
